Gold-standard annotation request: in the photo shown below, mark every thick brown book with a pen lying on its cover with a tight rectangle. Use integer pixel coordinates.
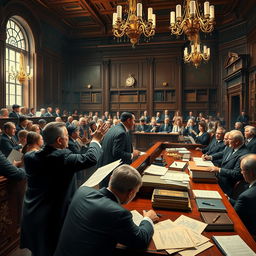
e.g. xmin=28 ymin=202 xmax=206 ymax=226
xmin=201 ymin=212 xmax=234 ymax=231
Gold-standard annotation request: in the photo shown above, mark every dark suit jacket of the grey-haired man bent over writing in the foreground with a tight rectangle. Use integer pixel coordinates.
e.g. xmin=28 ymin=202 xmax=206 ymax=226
xmin=54 ymin=186 xmax=153 ymax=256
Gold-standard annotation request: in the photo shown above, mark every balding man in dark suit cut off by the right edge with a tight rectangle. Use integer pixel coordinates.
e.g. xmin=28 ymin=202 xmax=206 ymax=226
xmin=234 ymin=154 xmax=256 ymax=236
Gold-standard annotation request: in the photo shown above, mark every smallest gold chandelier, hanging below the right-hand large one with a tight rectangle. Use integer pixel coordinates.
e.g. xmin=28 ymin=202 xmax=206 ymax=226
xmin=184 ymin=41 xmax=210 ymax=68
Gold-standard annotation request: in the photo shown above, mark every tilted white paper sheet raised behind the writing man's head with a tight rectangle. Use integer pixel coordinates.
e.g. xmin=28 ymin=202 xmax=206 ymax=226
xmin=82 ymin=159 xmax=121 ymax=187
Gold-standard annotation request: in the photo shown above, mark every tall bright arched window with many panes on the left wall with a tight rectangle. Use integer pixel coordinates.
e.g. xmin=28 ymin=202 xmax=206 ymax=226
xmin=5 ymin=18 xmax=32 ymax=107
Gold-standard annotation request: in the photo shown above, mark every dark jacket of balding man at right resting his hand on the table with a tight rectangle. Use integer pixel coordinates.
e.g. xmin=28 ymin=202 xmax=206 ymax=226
xmin=218 ymin=145 xmax=249 ymax=197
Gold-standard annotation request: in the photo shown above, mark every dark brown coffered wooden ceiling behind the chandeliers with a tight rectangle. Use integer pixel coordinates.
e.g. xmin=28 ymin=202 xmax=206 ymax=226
xmin=35 ymin=0 xmax=254 ymax=38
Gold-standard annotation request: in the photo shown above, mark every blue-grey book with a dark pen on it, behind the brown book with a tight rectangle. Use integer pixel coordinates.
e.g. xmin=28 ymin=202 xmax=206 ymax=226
xmin=196 ymin=198 xmax=227 ymax=212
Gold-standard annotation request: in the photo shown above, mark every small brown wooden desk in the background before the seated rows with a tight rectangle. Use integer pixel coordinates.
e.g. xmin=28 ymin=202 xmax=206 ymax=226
xmin=132 ymin=132 xmax=179 ymax=151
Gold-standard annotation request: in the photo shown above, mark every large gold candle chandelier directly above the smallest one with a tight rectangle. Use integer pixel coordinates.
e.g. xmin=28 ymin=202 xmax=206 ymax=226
xmin=170 ymin=0 xmax=215 ymax=42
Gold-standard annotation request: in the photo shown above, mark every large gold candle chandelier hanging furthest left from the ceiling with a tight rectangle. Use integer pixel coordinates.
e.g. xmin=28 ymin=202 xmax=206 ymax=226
xmin=113 ymin=0 xmax=156 ymax=47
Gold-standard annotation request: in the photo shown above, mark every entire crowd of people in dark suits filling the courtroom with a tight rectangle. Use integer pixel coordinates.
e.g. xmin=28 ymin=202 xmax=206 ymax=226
xmin=0 ymin=105 xmax=256 ymax=256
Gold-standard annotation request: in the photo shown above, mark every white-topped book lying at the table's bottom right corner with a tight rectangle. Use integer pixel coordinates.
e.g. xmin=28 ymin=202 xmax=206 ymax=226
xmin=212 ymin=235 xmax=256 ymax=256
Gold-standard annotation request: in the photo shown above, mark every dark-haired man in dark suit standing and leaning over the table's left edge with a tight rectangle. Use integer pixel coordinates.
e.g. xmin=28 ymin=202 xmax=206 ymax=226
xmin=101 ymin=112 xmax=140 ymax=166
